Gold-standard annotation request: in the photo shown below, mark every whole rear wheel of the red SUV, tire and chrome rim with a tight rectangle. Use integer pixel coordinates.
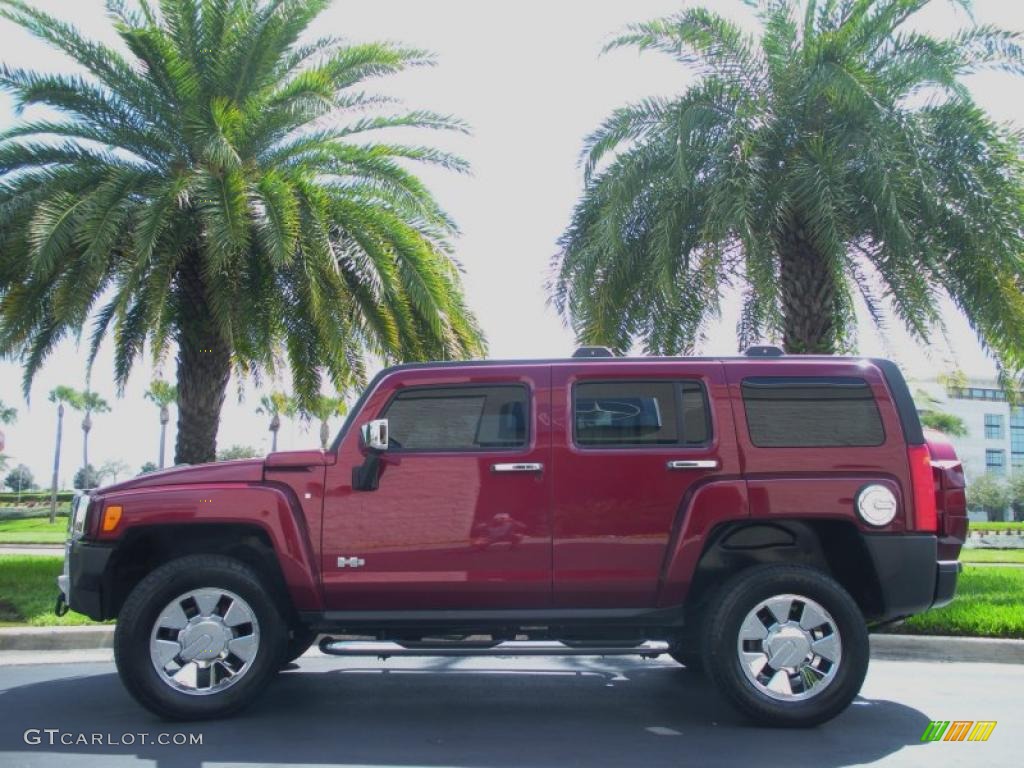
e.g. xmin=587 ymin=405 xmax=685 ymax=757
xmin=702 ymin=565 xmax=868 ymax=727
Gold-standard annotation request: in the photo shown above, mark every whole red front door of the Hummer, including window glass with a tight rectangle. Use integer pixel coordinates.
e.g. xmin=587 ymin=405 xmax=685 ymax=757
xmin=323 ymin=365 xmax=551 ymax=610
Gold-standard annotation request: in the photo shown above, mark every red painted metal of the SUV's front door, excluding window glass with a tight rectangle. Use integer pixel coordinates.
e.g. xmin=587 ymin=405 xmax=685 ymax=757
xmin=323 ymin=365 xmax=553 ymax=610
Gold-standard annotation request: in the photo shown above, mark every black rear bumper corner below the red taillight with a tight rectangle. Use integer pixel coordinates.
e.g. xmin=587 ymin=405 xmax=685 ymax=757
xmin=864 ymin=534 xmax=962 ymax=622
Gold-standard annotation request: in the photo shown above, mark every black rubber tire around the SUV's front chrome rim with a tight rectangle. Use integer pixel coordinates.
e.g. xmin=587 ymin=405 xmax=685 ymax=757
xmin=114 ymin=555 xmax=288 ymax=720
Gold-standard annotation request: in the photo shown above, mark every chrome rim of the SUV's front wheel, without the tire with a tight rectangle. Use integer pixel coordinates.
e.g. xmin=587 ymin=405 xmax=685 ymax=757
xmin=150 ymin=589 xmax=259 ymax=695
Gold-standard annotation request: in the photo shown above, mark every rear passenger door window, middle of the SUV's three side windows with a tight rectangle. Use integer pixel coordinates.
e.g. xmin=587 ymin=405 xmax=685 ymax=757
xmin=572 ymin=380 xmax=711 ymax=447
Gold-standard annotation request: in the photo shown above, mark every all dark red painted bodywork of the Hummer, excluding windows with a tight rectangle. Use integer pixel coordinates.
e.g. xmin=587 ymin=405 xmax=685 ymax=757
xmin=77 ymin=356 xmax=967 ymax=611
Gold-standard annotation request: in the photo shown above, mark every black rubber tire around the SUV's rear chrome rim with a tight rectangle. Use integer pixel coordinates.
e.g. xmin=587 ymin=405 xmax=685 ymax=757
xmin=701 ymin=565 xmax=869 ymax=727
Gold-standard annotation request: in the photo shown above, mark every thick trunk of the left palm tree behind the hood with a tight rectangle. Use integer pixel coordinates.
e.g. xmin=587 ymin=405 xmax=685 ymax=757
xmin=174 ymin=258 xmax=231 ymax=464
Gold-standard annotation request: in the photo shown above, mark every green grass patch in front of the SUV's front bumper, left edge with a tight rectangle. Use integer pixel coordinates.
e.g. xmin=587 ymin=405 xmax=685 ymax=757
xmin=0 ymin=555 xmax=101 ymax=627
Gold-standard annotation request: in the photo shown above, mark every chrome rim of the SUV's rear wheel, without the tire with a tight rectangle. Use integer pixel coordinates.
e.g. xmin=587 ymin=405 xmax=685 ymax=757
xmin=736 ymin=595 xmax=843 ymax=701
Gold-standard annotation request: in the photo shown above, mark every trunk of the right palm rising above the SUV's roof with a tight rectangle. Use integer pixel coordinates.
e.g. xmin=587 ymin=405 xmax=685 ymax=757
xmin=779 ymin=225 xmax=836 ymax=354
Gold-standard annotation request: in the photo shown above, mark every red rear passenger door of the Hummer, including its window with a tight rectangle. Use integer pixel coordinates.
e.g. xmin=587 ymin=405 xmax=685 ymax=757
xmin=552 ymin=360 xmax=738 ymax=608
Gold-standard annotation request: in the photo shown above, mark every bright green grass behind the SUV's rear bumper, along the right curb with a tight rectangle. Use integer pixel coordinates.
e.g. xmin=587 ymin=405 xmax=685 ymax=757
xmin=889 ymin=567 xmax=1024 ymax=638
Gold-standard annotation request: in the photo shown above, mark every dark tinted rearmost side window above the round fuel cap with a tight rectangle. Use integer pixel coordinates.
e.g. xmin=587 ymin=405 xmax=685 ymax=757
xmin=741 ymin=377 xmax=886 ymax=447
